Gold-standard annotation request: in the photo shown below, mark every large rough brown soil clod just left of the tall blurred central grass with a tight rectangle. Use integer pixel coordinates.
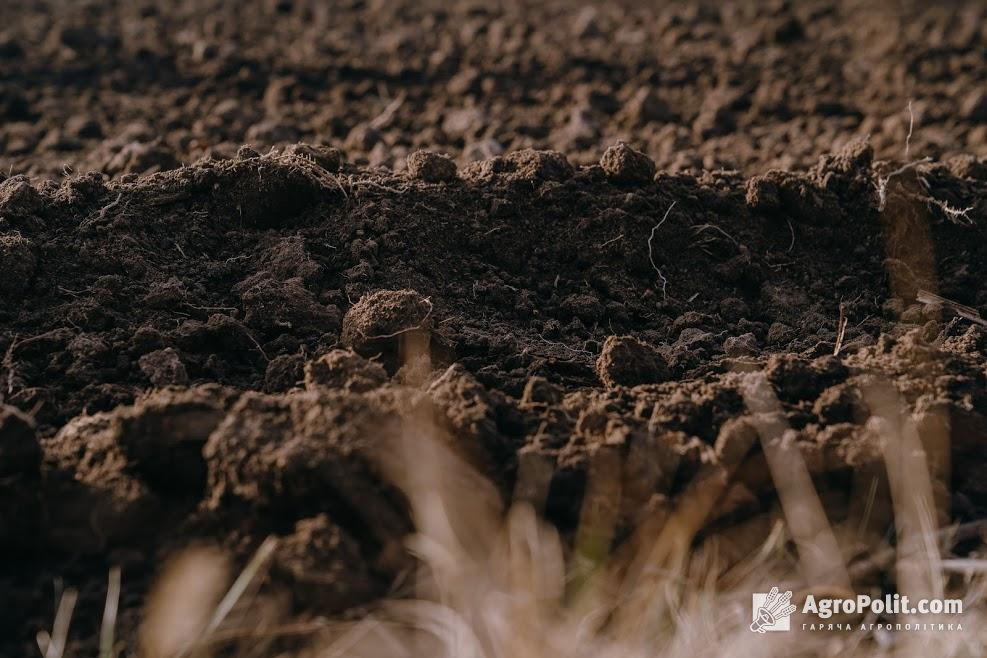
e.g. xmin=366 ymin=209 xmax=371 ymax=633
xmin=203 ymin=389 xmax=410 ymax=559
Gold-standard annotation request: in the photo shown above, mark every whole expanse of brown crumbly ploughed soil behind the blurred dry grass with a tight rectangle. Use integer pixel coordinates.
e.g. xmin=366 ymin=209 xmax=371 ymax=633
xmin=0 ymin=1 xmax=987 ymax=655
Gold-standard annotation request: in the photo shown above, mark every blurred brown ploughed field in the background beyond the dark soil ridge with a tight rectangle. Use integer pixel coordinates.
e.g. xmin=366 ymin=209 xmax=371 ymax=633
xmin=0 ymin=0 xmax=987 ymax=177
